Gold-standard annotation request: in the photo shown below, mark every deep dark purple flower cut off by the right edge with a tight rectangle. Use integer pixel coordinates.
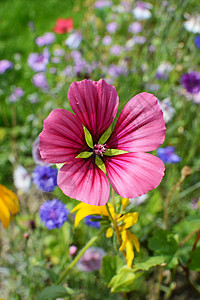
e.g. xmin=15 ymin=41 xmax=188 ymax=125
xmin=181 ymin=71 xmax=200 ymax=94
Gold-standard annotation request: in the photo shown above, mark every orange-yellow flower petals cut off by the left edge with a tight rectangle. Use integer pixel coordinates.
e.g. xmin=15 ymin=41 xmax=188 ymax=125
xmin=0 ymin=184 xmax=19 ymax=228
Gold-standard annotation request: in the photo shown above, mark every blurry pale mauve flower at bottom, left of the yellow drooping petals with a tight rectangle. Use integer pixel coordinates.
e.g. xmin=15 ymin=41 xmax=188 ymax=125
xmin=77 ymin=247 xmax=106 ymax=272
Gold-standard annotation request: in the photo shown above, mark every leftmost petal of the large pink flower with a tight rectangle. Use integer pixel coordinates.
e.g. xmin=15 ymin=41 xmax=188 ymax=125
xmin=39 ymin=109 xmax=89 ymax=163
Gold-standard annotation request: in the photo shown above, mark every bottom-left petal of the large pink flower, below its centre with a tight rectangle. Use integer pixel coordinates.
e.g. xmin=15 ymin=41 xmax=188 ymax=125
xmin=57 ymin=158 xmax=110 ymax=206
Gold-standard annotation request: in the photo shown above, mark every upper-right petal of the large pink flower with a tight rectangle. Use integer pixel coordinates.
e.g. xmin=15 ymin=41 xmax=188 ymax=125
xmin=106 ymin=93 xmax=165 ymax=152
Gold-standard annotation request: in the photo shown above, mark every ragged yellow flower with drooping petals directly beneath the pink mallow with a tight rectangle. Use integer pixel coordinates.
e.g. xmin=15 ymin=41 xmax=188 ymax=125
xmin=71 ymin=198 xmax=140 ymax=267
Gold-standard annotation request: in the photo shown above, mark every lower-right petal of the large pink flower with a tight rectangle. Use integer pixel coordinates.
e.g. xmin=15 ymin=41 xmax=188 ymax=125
xmin=105 ymin=153 xmax=165 ymax=198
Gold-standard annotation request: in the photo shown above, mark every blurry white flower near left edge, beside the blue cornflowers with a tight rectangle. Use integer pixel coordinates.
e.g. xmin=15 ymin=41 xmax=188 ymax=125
xmin=13 ymin=165 xmax=31 ymax=193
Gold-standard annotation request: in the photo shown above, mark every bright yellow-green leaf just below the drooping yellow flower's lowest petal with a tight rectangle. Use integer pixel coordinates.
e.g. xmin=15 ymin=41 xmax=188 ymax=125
xmin=108 ymin=266 xmax=143 ymax=293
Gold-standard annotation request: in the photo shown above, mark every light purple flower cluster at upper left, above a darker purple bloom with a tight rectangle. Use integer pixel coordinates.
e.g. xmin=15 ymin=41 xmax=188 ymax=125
xmin=28 ymin=48 xmax=50 ymax=72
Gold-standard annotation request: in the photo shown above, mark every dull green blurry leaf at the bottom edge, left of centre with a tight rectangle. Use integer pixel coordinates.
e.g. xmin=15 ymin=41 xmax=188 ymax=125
xmin=37 ymin=285 xmax=74 ymax=300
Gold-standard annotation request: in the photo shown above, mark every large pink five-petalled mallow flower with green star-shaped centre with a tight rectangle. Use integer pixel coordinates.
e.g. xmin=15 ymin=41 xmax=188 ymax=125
xmin=39 ymin=79 xmax=165 ymax=206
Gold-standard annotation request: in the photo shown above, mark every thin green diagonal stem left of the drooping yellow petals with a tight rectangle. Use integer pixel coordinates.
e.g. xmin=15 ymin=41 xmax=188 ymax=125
xmin=56 ymin=228 xmax=105 ymax=285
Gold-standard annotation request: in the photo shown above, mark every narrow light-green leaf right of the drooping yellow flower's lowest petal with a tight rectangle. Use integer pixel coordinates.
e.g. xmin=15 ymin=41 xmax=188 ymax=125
xmin=133 ymin=256 xmax=165 ymax=272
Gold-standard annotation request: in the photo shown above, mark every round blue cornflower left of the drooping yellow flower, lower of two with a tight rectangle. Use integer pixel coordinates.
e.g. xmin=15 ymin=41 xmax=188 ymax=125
xmin=39 ymin=199 xmax=69 ymax=229
